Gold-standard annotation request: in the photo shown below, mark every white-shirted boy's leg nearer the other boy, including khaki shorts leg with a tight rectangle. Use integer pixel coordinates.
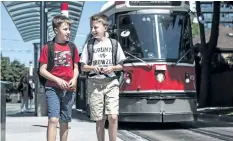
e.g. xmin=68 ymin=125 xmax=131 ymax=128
xmin=87 ymin=80 xmax=105 ymax=141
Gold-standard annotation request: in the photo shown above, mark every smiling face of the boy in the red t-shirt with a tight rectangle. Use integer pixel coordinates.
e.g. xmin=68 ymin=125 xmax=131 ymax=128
xmin=55 ymin=23 xmax=70 ymax=41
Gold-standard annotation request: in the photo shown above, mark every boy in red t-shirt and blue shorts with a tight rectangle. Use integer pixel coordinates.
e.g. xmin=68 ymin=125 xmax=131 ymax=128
xmin=39 ymin=16 xmax=79 ymax=141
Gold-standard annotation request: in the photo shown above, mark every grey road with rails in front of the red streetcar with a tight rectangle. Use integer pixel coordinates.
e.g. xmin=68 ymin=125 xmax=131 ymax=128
xmin=119 ymin=122 xmax=233 ymax=141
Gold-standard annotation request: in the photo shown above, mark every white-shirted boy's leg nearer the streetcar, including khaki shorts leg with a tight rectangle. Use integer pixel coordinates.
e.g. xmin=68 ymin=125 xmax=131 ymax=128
xmin=105 ymin=79 xmax=119 ymax=141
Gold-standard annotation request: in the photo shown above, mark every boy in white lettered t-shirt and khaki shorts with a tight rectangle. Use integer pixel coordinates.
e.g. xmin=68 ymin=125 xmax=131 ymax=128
xmin=80 ymin=14 xmax=126 ymax=141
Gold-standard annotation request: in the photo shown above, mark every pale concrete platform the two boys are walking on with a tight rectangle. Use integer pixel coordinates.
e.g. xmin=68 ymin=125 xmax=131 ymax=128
xmin=6 ymin=103 xmax=122 ymax=141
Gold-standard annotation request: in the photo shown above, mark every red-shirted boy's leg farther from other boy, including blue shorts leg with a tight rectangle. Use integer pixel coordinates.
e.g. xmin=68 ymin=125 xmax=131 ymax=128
xmin=45 ymin=87 xmax=60 ymax=141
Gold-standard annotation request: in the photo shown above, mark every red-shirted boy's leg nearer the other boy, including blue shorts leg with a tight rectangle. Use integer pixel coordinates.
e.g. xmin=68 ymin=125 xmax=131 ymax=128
xmin=60 ymin=91 xmax=75 ymax=141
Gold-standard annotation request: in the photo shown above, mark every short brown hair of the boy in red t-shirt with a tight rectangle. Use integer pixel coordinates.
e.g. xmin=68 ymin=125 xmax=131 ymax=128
xmin=52 ymin=15 xmax=72 ymax=30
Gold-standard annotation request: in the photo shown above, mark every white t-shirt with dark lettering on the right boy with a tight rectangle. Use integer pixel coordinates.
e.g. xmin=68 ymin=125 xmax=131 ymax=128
xmin=80 ymin=38 xmax=126 ymax=79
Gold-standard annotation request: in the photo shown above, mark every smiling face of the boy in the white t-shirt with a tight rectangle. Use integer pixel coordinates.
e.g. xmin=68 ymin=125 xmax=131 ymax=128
xmin=91 ymin=21 xmax=107 ymax=38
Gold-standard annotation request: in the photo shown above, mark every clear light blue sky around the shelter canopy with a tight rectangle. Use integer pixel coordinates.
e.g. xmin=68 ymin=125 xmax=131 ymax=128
xmin=1 ymin=1 xmax=106 ymax=66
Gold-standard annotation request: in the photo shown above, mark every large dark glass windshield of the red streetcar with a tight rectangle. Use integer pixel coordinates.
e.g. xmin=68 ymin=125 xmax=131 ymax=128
xmin=119 ymin=12 xmax=193 ymax=60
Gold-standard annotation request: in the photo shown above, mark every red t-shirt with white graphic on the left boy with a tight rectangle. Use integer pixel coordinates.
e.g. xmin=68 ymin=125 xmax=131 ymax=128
xmin=39 ymin=43 xmax=79 ymax=88
